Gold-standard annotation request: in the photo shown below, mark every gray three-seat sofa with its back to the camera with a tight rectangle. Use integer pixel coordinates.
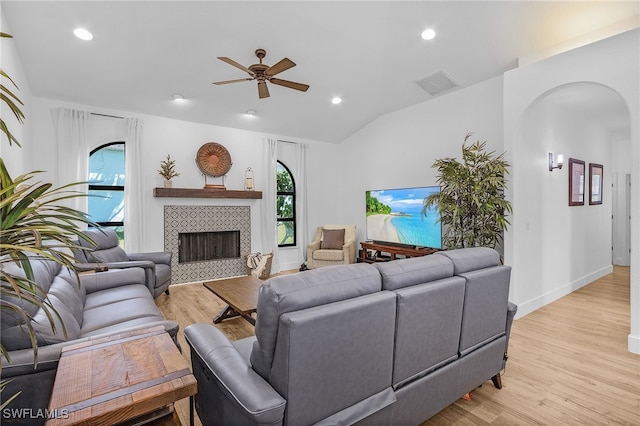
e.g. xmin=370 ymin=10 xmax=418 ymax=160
xmin=185 ymin=248 xmax=517 ymax=426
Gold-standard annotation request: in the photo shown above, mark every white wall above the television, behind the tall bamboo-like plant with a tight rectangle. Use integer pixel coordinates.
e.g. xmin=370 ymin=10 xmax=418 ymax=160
xmin=332 ymin=77 xmax=503 ymax=246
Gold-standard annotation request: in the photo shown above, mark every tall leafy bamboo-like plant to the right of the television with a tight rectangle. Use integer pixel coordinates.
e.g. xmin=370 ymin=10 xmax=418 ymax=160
xmin=422 ymin=133 xmax=512 ymax=249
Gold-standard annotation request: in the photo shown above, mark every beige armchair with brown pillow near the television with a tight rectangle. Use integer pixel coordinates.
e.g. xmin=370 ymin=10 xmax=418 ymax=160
xmin=307 ymin=225 xmax=356 ymax=269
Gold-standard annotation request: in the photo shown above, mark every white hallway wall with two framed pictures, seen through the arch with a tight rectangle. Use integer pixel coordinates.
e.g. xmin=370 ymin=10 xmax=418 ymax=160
xmin=511 ymin=94 xmax=611 ymax=315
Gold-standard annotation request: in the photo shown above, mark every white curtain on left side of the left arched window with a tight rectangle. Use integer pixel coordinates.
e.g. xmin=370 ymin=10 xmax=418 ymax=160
xmin=51 ymin=108 xmax=91 ymax=216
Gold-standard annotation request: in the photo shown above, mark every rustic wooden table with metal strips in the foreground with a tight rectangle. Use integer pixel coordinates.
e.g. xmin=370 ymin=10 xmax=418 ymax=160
xmin=46 ymin=326 xmax=198 ymax=426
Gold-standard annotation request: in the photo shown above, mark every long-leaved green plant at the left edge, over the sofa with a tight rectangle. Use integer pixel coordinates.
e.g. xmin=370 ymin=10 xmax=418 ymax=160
xmin=0 ymin=33 xmax=93 ymax=408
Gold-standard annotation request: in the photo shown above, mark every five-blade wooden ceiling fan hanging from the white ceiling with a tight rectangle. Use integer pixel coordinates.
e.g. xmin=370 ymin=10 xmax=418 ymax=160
xmin=213 ymin=49 xmax=309 ymax=99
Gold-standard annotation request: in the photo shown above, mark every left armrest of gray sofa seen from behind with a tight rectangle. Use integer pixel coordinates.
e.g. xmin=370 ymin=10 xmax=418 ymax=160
xmin=184 ymin=324 xmax=286 ymax=425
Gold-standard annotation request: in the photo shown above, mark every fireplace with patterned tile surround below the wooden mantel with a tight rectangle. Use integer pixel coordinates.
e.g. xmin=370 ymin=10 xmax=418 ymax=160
xmin=164 ymin=206 xmax=251 ymax=284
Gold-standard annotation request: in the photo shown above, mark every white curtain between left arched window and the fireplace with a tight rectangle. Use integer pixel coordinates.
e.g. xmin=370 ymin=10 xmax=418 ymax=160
xmin=124 ymin=118 xmax=144 ymax=252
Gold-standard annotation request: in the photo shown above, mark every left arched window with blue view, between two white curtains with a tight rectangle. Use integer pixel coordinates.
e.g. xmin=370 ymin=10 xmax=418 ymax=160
xmin=88 ymin=142 xmax=125 ymax=246
